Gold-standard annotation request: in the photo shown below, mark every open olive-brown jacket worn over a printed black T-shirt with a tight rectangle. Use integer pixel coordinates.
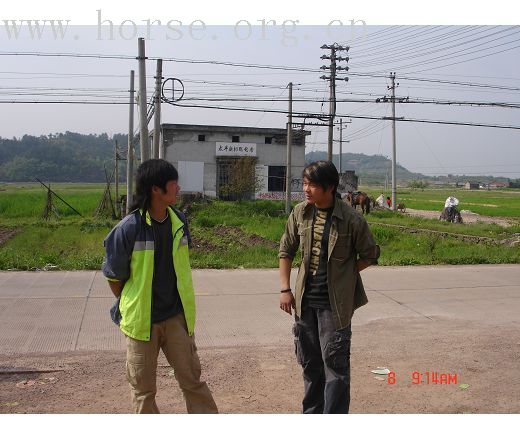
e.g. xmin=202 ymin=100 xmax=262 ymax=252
xmin=278 ymin=198 xmax=380 ymax=330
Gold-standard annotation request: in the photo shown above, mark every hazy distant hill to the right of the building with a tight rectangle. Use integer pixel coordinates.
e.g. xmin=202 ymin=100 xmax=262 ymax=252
xmin=305 ymin=151 xmax=431 ymax=185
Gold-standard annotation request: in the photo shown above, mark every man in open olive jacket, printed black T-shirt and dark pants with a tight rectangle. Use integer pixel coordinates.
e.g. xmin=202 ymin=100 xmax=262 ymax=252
xmin=278 ymin=161 xmax=380 ymax=413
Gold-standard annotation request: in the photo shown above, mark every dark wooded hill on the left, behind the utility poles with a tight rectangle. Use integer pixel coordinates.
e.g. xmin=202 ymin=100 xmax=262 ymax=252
xmin=0 ymin=131 xmax=127 ymax=182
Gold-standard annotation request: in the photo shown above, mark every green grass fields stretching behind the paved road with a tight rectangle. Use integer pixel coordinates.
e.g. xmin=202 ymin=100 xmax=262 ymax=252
xmin=0 ymin=184 xmax=520 ymax=270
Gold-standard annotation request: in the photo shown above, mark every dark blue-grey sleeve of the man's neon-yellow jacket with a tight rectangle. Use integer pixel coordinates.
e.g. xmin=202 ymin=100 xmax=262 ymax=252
xmin=102 ymin=224 xmax=134 ymax=281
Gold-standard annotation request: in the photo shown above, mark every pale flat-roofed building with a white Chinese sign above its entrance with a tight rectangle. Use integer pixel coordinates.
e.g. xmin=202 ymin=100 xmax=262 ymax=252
xmin=161 ymin=124 xmax=311 ymax=200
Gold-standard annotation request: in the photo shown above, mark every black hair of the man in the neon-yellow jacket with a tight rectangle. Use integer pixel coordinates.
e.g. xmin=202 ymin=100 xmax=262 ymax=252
xmin=130 ymin=159 xmax=179 ymax=212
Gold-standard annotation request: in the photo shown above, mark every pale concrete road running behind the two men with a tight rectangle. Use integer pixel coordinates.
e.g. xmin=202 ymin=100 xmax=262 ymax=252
xmin=0 ymin=265 xmax=520 ymax=354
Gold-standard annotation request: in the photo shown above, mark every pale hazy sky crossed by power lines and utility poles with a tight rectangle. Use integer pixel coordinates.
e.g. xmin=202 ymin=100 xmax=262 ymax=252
xmin=0 ymin=21 xmax=520 ymax=178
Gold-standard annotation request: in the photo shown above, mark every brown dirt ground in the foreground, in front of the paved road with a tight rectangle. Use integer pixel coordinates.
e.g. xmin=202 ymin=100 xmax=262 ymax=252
xmin=0 ymin=317 xmax=520 ymax=413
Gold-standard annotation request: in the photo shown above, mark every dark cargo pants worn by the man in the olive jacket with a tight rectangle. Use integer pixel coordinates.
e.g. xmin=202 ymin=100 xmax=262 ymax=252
xmin=293 ymin=307 xmax=352 ymax=414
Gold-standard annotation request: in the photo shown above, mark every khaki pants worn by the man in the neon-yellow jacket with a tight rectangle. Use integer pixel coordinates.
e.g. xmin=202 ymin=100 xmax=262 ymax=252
xmin=126 ymin=313 xmax=218 ymax=414
